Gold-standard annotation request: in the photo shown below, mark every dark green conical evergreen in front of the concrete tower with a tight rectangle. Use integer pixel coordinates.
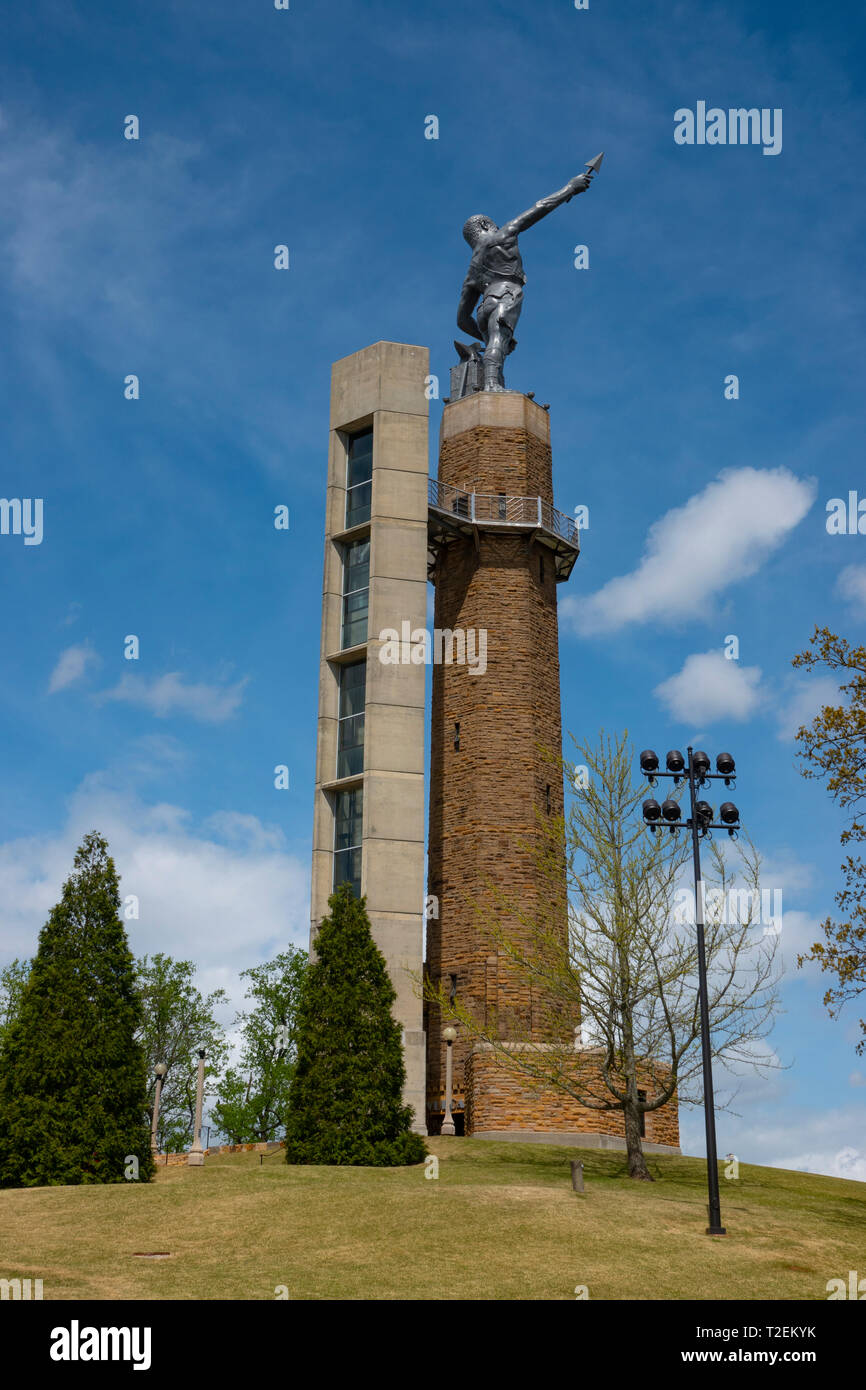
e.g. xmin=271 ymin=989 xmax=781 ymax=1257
xmin=286 ymin=884 xmax=427 ymax=1168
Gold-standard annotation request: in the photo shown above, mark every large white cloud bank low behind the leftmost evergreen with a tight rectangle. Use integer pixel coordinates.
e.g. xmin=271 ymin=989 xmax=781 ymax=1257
xmin=0 ymin=766 xmax=310 ymax=1004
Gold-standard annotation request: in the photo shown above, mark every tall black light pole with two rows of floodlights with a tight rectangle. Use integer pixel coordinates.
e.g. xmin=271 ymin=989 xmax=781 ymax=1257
xmin=641 ymin=746 xmax=740 ymax=1236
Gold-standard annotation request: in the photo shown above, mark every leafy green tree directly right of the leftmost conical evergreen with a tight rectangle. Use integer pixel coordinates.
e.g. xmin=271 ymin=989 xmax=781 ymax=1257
xmin=136 ymin=952 xmax=228 ymax=1154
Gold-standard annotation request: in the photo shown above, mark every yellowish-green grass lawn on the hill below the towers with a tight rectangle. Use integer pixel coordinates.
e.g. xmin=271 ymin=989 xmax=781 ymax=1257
xmin=0 ymin=1138 xmax=866 ymax=1300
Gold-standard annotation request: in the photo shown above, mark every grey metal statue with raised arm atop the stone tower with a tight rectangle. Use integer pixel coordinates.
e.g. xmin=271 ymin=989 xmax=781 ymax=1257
xmin=455 ymin=153 xmax=603 ymax=391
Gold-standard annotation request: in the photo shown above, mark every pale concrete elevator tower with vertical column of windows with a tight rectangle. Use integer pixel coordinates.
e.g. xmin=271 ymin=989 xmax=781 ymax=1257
xmin=310 ymin=342 xmax=430 ymax=1134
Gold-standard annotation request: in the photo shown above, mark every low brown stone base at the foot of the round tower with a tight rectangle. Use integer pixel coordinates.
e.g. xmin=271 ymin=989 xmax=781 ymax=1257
xmin=464 ymin=1043 xmax=680 ymax=1154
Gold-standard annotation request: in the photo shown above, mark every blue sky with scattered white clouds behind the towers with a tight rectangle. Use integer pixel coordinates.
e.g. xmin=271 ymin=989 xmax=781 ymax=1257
xmin=0 ymin=0 xmax=866 ymax=1179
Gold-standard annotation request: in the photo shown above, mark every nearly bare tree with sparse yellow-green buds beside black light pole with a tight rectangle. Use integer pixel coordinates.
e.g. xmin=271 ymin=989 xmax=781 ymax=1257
xmin=427 ymin=734 xmax=778 ymax=1180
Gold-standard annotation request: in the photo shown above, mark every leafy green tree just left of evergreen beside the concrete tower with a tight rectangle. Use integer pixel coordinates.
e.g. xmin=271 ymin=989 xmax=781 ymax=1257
xmin=211 ymin=947 xmax=307 ymax=1144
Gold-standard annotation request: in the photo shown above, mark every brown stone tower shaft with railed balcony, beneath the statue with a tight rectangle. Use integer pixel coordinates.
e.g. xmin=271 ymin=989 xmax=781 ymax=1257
xmin=427 ymin=391 xmax=578 ymax=1137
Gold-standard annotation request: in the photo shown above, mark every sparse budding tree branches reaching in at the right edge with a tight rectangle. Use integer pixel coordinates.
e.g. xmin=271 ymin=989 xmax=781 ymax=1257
xmin=791 ymin=627 xmax=866 ymax=1054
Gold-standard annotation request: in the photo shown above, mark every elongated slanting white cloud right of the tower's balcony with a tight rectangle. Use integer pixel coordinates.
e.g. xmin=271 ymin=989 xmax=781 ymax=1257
xmin=560 ymin=468 xmax=815 ymax=634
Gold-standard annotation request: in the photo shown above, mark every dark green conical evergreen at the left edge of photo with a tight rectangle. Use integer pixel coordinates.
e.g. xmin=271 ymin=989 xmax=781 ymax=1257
xmin=0 ymin=831 xmax=153 ymax=1187
